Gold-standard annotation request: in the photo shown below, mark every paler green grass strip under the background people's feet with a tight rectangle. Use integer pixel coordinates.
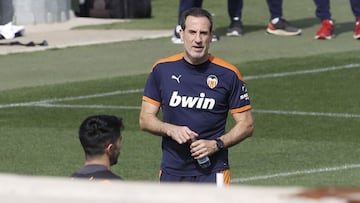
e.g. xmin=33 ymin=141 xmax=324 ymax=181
xmin=0 ymin=0 xmax=360 ymax=90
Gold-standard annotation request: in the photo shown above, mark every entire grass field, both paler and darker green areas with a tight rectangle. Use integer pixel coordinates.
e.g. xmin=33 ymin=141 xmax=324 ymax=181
xmin=0 ymin=0 xmax=360 ymax=187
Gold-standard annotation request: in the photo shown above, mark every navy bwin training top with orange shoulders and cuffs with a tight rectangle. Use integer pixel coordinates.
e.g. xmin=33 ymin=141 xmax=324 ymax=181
xmin=143 ymin=53 xmax=251 ymax=176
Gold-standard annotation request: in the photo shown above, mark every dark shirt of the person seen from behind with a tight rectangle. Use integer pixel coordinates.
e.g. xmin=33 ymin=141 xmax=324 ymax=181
xmin=71 ymin=164 xmax=123 ymax=180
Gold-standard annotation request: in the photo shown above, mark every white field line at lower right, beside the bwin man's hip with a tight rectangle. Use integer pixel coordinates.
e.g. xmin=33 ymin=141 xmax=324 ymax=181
xmin=231 ymin=164 xmax=360 ymax=183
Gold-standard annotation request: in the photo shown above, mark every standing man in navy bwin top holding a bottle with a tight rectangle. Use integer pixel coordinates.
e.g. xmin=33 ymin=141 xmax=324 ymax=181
xmin=139 ymin=8 xmax=254 ymax=184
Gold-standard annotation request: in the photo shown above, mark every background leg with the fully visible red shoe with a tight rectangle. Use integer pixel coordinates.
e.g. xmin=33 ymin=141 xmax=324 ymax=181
xmin=314 ymin=0 xmax=334 ymax=39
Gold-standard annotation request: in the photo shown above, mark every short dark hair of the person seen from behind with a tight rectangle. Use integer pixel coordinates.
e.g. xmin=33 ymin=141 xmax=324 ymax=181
xmin=79 ymin=115 xmax=124 ymax=156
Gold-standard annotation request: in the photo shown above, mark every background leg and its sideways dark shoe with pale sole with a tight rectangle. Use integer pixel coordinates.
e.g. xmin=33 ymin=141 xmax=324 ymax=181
xmin=266 ymin=0 xmax=301 ymax=36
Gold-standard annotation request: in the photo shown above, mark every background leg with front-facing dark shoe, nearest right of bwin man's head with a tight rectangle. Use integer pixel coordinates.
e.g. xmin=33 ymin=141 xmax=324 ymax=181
xmin=226 ymin=0 xmax=243 ymax=36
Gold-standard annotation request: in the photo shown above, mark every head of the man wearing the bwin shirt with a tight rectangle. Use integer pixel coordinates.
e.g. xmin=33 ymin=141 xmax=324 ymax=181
xmin=180 ymin=16 xmax=212 ymax=65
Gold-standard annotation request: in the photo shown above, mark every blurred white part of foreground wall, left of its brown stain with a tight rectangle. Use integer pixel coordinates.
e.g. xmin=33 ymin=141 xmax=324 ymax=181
xmin=0 ymin=174 xmax=306 ymax=203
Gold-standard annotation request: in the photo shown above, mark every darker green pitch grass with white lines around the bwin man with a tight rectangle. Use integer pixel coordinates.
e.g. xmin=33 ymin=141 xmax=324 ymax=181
xmin=0 ymin=53 xmax=360 ymax=186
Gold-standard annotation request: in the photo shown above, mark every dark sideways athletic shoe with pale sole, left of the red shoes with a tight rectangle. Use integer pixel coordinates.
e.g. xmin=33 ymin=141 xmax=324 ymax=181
xmin=266 ymin=18 xmax=301 ymax=36
